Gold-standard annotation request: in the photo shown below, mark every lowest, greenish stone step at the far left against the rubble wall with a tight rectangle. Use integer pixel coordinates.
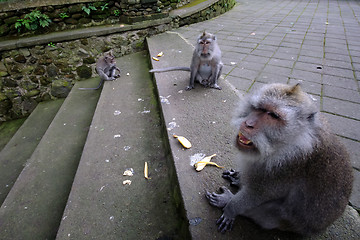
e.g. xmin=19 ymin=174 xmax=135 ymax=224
xmin=0 ymin=99 xmax=64 ymax=205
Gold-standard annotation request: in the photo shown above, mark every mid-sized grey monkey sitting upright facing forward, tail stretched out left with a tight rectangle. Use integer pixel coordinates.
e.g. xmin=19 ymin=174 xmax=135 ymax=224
xmin=150 ymin=32 xmax=223 ymax=90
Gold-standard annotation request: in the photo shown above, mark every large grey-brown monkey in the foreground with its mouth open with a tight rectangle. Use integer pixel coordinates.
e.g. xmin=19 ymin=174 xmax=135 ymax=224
xmin=206 ymin=84 xmax=353 ymax=235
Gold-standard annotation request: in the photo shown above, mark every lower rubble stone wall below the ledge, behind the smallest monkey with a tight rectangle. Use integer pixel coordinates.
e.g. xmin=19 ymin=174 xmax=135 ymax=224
xmin=0 ymin=0 xmax=235 ymax=122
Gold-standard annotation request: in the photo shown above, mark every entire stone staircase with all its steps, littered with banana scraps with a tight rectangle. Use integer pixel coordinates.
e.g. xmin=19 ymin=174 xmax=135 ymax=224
xmin=0 ymin=33 xmax=360 ymax=240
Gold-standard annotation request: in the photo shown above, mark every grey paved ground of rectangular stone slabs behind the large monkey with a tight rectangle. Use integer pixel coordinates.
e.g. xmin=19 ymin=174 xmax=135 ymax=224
xmin=176 ymin=0 xmax=360 ymax=208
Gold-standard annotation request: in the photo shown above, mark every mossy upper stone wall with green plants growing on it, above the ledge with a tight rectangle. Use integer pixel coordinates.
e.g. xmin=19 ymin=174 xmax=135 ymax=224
xmin=0 ymin=0 xmax=190 ymax=39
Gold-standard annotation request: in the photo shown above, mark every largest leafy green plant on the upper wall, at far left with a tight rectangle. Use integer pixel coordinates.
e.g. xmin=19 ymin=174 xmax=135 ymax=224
xmin=15 ymin=10 xmax=51 ymax=31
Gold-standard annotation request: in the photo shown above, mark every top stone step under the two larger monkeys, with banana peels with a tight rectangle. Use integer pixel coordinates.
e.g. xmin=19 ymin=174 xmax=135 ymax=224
xmin=147 ymin=32 xmax=359 ymax=240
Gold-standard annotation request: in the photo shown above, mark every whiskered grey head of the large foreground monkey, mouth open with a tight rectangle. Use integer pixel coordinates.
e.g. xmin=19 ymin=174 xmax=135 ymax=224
xmin=234 ymin=84 xmax=315 ymax=159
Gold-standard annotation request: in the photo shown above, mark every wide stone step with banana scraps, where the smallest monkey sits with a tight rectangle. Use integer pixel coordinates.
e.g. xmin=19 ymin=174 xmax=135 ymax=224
xmin=56 ymin=52 xmax=186 ymax=240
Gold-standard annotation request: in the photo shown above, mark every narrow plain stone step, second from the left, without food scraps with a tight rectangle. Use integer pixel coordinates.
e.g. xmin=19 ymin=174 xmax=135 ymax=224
xmin=0 ymin=78 xmax=100 ymax=239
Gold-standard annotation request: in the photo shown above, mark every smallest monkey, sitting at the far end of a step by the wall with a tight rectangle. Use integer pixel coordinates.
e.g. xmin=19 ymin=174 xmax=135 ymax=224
xmin=79 ymin=51 xmax=120 ymax=90
